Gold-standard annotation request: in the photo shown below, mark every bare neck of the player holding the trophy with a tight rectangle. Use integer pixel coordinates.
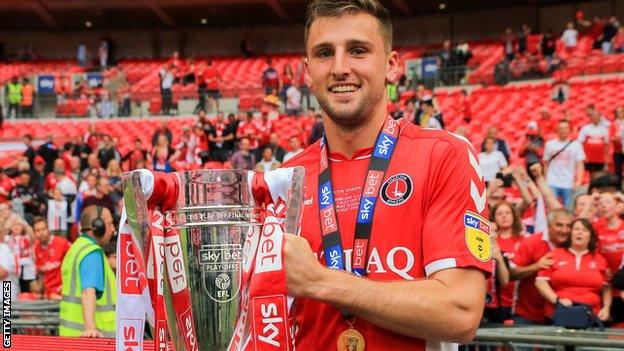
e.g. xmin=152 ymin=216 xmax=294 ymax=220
xmin=323 ymin=113 xmax=386 ymax=158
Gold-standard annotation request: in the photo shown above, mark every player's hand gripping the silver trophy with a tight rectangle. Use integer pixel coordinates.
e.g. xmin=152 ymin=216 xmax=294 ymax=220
xmin=284 ymin=234 xmax=327 ymax=297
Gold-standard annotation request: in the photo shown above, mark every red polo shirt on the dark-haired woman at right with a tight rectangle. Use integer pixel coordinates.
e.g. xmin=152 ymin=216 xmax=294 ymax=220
xmin=536 ymin=247 xmax=609 ymax=317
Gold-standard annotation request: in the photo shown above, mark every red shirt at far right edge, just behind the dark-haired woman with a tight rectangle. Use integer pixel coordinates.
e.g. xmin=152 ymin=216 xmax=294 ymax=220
xmin=593 ymin=217 xmax=624 ymax=273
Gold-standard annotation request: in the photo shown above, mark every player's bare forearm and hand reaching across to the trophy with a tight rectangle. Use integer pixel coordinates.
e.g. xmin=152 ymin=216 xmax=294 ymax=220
xmin=285 ymin=235 xmax=485 ymax=342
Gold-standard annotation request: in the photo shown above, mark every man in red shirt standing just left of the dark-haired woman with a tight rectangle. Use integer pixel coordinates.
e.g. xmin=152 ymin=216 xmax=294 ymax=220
xmin=510 ymin=209 xmax=572 ymax=325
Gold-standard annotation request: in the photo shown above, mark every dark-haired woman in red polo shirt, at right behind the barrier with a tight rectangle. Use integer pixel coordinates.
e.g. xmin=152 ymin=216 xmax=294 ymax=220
xmin=535 ymin=218 xmax=611 ymax=321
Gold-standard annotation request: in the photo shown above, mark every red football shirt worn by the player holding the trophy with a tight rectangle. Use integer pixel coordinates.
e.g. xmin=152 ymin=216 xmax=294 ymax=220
xmin=285 ymin=123 xmax=492 ymax=350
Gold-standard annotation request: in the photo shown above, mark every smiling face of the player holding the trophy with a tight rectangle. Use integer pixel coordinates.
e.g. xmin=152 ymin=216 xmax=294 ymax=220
xmin=306 ymin=13 xmax=398 ymax=131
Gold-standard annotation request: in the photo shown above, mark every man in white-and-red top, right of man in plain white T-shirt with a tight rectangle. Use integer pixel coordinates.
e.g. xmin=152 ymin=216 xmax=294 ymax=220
xmin=577 ymin=104 xmax=609 ymax=174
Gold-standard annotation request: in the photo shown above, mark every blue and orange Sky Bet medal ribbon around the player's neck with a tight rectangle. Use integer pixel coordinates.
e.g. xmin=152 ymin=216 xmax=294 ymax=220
xmin=318 ymin=117 xmax=399 ymax=277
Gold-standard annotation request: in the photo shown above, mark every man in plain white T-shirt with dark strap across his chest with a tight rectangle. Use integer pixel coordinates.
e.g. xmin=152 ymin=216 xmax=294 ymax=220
xmin=544 ymin=120 xmax=585 ymax=207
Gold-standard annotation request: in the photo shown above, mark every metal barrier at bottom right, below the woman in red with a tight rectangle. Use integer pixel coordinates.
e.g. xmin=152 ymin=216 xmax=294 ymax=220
xmin=464 ymin=327 xmax=624 ymax=351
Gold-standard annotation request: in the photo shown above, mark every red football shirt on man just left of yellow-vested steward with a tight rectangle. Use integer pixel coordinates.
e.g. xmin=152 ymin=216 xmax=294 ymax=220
xmin=34 ymin=235 xmax=71 ymax=296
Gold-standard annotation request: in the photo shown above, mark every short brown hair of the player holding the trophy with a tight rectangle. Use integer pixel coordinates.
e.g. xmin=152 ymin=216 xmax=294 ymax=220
xmin=304 ymin=0 xmax=392 ymax=51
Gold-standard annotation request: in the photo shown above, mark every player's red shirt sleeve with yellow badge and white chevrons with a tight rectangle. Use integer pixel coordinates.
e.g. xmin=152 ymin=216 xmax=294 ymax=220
xmin=422 ymin=140 xmax=492 ymax=276
